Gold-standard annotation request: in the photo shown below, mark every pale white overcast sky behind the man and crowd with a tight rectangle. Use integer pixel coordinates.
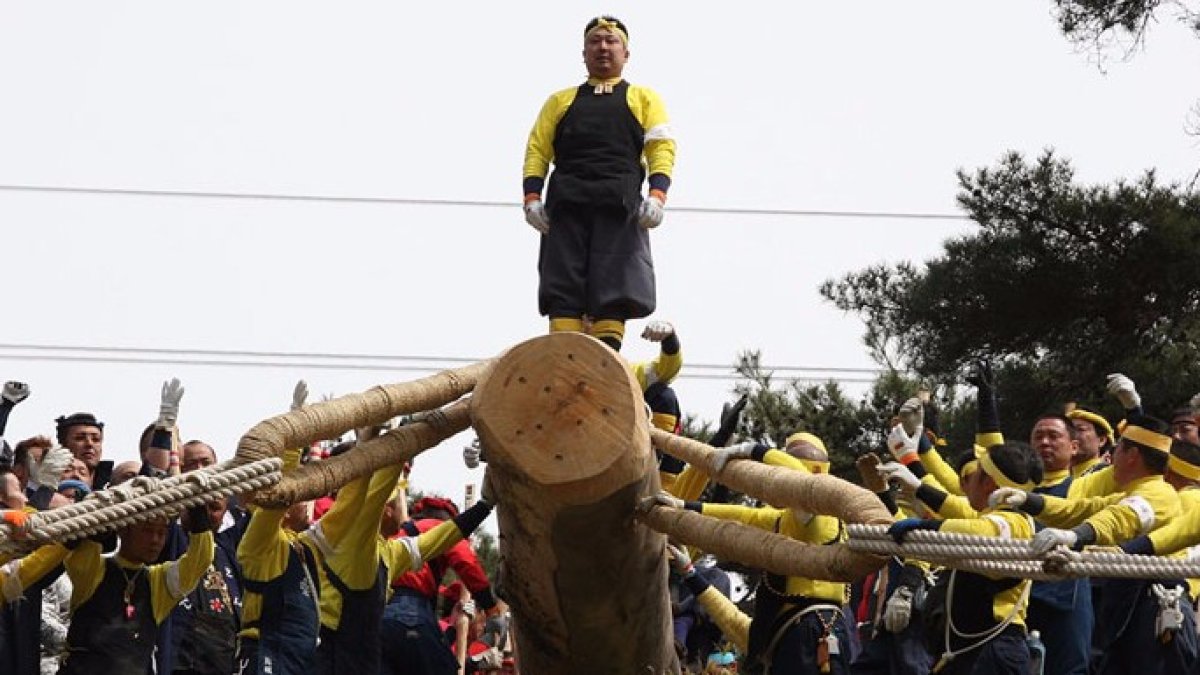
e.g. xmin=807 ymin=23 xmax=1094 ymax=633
xmin=0 ymin=0 xmax=1200 ymax=498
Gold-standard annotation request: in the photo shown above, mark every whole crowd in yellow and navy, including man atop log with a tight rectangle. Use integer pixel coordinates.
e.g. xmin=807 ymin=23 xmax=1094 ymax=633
xmin=0 ymin=17 xmax=1200 ymax=675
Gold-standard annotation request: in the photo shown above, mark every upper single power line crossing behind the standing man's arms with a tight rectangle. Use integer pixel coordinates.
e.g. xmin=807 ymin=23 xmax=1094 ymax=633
xmin=0 ymin=185 xmax=971 ymax=221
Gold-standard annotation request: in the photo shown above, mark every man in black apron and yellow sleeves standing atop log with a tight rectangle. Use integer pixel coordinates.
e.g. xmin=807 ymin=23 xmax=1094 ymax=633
xmin=522 ymin=17 xmax=676 ymax=350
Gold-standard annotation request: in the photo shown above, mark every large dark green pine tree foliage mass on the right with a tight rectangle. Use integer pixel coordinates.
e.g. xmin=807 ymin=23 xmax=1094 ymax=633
xmin=821 ymin=151 xmax=1200 ymax=427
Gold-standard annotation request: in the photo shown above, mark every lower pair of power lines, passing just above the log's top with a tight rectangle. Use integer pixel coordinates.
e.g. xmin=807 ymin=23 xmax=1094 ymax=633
xmin=0 ymin=345 xmax=878 ymax=383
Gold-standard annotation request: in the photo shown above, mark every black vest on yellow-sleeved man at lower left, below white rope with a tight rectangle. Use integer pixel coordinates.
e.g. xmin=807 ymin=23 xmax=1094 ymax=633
xmin=59 ymin=558 xmax=158 ymax=675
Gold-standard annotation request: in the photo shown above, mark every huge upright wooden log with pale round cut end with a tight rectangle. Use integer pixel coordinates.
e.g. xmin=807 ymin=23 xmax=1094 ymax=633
xmin=472 ymin=333 xmax=679 ymax=675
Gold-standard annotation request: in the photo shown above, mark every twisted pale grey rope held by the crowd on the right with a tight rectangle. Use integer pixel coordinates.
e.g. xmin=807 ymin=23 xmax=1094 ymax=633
xmin=847 ymin=525 xmax=1200 ymax=580
